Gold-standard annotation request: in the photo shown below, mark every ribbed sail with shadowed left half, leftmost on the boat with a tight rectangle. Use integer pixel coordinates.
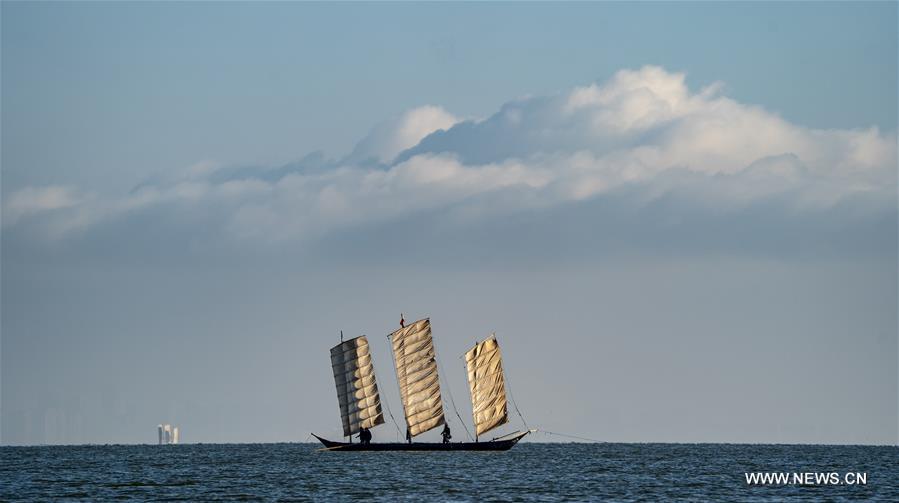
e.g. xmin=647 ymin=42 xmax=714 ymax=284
xmin=331 ymin=336 xmax=384 ymax=437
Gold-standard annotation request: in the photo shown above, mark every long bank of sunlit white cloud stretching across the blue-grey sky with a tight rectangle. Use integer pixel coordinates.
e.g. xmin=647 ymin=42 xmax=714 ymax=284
xmin=4 ymin=67 xmax=897 ymax=248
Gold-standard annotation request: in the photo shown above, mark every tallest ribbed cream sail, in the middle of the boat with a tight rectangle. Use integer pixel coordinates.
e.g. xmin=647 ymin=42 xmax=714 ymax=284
xmin=390 ymin=319 xmax=443 ymax=437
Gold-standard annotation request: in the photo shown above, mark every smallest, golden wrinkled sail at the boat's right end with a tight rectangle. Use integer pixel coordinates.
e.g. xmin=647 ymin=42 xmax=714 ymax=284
xmin=465 ymin=337 xmax=509 ymax=435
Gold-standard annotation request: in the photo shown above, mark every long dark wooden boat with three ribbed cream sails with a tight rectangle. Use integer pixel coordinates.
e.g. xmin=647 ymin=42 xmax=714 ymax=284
xmin=312 ymin=318 xmax=531 ymax=451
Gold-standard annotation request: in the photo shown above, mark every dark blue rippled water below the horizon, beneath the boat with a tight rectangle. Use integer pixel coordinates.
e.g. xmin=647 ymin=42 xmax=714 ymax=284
xmin=0 ymin=443 xmax=899 ymax=501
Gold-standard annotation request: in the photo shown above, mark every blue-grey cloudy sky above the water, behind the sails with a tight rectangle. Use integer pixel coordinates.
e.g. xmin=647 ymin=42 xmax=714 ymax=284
xmin=0 ymin=2 xmax=899 ymax=445
